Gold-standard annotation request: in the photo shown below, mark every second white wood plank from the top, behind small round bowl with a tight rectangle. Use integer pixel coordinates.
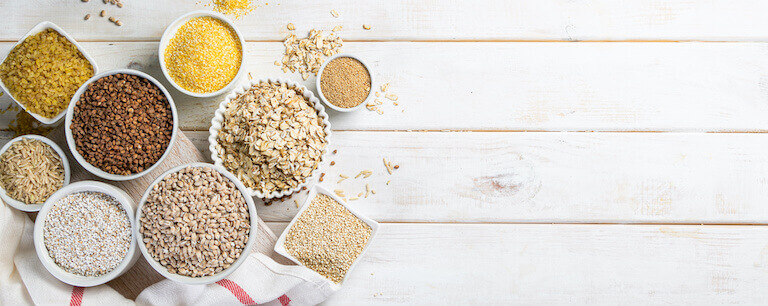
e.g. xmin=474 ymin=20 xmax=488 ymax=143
xmin=0 ymin=42 xmax=768 ymax=131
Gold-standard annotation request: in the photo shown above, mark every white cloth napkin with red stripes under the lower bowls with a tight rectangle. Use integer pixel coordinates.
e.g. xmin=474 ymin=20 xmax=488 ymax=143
xmin=0 ymin=201 xmax=336 ymax=306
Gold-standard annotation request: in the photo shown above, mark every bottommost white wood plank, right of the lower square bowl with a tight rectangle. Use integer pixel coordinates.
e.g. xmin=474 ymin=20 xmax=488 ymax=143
xmin=262 ymin=223 xmax=768 ymax=305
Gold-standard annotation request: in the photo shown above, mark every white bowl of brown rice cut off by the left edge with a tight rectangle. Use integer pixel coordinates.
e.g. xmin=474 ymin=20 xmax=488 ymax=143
xmin=0 ymin=135 xmax=71 ymax=212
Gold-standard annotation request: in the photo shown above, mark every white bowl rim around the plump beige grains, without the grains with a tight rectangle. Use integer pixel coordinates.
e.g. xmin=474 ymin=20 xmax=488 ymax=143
xmin=133 ymin=163 xmax=259 ymax=285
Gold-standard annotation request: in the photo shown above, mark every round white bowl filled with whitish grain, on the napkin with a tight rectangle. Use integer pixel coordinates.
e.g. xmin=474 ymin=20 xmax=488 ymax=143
xmin=34 ymin=181 xmax=139 ymax=287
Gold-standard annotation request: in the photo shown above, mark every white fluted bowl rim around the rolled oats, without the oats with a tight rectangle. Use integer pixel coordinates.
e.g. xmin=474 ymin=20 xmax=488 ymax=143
xmin=208 ymin=78 xmax=331 ymax=200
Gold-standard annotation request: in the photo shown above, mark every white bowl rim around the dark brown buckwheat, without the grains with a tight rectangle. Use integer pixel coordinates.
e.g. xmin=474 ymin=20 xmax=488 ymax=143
xmin=64 ymin=69 xmax=179 ymax=181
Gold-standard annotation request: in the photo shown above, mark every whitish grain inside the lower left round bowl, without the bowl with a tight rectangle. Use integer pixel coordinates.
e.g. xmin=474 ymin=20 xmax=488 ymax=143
xmin=43 ymin=192 xmax=131 ymax=276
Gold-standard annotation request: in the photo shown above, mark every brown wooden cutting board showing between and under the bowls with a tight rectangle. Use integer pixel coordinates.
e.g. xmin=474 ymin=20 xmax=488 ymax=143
xmin=45 ymin=124 xmax=291 ymax=300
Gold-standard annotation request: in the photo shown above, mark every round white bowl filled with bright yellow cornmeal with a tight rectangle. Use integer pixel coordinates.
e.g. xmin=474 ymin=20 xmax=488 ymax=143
xmin=158 ymin=11 xmax=245 ymax=98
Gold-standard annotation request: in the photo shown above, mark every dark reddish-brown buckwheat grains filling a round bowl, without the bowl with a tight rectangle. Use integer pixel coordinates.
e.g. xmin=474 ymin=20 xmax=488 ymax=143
xmin=71 ymin=74 xmax=173 ymax=175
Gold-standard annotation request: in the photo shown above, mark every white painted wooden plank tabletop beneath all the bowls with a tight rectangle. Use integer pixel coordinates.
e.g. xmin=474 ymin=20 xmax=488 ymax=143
xmin=0 ymin=0 xmax=768 ymax=305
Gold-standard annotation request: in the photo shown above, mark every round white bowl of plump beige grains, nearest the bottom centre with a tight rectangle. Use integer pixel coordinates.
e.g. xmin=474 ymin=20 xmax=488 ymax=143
xmin=134 ymin=163 xmax=258 ymax=285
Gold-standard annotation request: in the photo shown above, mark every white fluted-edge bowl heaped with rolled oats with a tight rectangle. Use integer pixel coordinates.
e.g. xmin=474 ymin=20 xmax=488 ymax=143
xmin=208 ymin=78 xmax=331 ymax=200
